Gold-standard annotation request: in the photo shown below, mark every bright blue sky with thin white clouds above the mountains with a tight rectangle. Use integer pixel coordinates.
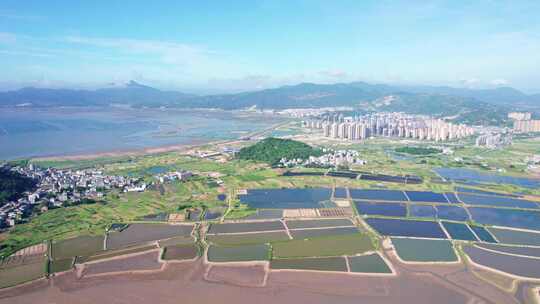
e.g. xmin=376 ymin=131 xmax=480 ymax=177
xmin=0 ymin=0 xmax=540 ymax=93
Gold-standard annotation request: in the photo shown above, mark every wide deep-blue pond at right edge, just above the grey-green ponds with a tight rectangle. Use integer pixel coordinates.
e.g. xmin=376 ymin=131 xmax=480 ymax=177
xmin=468 ymin=207 xmax=540 ymax=230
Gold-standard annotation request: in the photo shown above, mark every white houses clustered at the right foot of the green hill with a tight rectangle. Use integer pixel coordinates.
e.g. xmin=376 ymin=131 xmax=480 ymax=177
xmin=279 ymin=150 xmax=367 ymax=168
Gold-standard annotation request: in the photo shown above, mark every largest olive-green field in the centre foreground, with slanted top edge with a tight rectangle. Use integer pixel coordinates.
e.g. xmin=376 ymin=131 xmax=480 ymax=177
xmin=272 ymin=233 xmax=375 ymax=258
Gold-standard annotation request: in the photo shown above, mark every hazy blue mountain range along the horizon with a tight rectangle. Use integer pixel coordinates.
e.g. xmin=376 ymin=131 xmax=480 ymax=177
xmin=0 ymin=81 xmax=540 ymax=124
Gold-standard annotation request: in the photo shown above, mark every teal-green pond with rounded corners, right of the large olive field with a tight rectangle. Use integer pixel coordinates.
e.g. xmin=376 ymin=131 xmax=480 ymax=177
xmin=392 ymin=238 xmax=458 ymax=262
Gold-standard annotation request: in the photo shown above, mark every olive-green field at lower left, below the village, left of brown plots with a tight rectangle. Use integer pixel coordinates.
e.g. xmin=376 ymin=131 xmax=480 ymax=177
xmin=51 ymin=235 xmax=104 ymax=260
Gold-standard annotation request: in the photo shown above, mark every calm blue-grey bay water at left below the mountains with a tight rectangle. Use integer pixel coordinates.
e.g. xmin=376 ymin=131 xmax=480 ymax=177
xmin=0 ymin=108 xmax=280 ymax=160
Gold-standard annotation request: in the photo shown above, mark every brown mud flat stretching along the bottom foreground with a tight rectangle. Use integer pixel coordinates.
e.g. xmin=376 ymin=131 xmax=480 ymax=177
xmin=0 ymin=260 xmax=528 ymax=304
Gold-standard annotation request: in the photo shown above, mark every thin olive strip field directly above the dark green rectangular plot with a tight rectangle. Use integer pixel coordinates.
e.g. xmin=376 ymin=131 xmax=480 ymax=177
xmin=206 ymin=231 xmax=289 ymax=245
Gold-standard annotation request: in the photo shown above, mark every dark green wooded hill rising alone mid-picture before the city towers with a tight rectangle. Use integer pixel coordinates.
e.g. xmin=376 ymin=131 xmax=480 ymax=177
xmin=237 ymin=137 xmax=322 ymax=164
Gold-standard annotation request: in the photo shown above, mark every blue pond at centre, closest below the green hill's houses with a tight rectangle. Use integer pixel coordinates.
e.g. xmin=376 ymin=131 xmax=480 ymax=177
xmin=238 ymin=188 xmax=332 ymax=209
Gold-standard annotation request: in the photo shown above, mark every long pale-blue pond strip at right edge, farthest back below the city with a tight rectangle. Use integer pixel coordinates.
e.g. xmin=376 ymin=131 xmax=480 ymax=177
xmin=434 ymin=168 xmax=540 ymax=189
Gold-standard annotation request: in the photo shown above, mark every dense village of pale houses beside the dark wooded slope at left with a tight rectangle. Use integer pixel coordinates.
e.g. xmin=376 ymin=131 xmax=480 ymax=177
xmin=0 ymin=164 xmax=146 ymax=228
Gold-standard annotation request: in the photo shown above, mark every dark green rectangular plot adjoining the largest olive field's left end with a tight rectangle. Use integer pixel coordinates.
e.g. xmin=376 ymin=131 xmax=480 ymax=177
xmin=208 ymin=244 xmax=270 ymax=262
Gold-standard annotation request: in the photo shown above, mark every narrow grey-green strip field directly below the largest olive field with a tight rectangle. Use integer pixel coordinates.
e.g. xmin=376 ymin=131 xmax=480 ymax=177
xmin=270 ymin=257 xmax=347 ymax=272
